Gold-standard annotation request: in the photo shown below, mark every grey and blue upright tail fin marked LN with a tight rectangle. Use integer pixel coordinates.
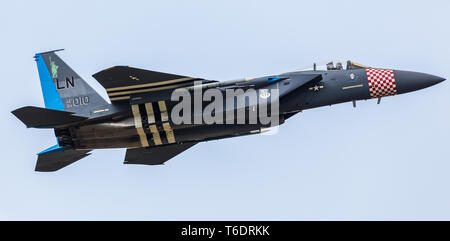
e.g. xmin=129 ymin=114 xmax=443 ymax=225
xmin=34 ymin=50 xmax=108 ymax=117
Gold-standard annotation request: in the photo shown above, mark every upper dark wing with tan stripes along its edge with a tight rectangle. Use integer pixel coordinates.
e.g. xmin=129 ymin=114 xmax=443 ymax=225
xmin=93 ymin=66 xmax=214 ymax=101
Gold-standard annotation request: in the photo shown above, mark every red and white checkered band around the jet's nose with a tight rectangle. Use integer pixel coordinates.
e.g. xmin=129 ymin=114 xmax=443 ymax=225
xmin=366 ymin=69 xmax=397 ymax=98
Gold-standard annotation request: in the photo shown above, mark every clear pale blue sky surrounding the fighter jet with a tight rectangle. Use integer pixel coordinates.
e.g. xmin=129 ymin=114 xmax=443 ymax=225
xmin=0 ymin=0 xmax=450 ymax=220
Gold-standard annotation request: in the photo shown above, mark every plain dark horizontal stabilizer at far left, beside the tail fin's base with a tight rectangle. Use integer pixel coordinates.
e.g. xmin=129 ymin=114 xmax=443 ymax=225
xmin=12 ymin=106 xmax=87 ymax=128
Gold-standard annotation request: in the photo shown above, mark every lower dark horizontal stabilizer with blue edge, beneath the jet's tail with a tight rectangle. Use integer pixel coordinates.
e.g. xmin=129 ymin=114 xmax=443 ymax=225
xmin=35 ymin=148 xmax=91 ymax=172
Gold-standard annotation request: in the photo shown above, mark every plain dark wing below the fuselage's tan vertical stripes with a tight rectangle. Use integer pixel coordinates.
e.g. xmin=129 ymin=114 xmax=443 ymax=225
xmin=124 ymin=142 xmax=197 ymax=165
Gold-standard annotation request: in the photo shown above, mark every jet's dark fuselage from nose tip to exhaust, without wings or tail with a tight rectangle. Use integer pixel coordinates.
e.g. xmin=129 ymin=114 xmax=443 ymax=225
xmin=61 ymin=65 xmax=444 ymax=149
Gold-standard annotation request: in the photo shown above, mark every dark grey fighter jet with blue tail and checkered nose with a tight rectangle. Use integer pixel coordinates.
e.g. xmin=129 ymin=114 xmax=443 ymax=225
xmin=12 ymin=50 xmax=445 ymax=172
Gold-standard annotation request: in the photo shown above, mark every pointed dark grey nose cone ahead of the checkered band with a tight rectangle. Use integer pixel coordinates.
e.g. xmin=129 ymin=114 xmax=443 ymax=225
xmin=394 ymin=70 xmax=445 ymax=94
